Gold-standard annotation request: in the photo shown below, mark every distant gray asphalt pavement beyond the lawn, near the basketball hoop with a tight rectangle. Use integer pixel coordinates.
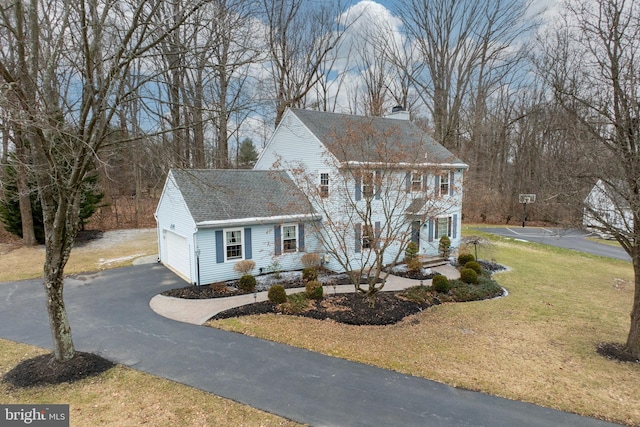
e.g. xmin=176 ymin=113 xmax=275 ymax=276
xmin=476 ymin=227 xmax=631 ymax=261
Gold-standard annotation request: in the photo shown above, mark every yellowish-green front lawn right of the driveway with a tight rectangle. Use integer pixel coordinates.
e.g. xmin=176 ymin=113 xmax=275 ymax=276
xmin=208 ymin=235 xmax=640 ymax=425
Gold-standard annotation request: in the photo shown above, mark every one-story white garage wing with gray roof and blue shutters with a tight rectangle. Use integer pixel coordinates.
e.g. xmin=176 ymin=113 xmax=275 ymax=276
xmin=155 ymin=169 xmax=320 ymax=284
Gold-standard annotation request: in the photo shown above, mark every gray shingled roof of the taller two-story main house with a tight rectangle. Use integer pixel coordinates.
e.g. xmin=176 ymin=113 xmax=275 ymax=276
xmin=291 ymin=109 xmax=467 ymax=168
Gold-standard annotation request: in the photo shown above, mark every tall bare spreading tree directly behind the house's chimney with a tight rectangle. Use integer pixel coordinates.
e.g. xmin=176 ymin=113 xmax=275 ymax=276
xmin=395 ymin=0 xmax=533 ymax=150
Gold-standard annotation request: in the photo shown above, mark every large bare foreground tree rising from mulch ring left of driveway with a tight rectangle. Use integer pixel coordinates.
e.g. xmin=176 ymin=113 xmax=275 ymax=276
xmin=0 ymin=0 xmax=198 ymax=361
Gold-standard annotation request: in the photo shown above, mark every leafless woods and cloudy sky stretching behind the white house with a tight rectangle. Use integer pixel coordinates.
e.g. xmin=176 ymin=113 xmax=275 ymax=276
xmin=0 ymin=0 xmax=617 ymax=234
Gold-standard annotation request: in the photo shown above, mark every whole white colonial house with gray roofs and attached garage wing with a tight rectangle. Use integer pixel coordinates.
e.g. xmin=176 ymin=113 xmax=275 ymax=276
xmin=156 ymin=109 xmax=468 ymax=284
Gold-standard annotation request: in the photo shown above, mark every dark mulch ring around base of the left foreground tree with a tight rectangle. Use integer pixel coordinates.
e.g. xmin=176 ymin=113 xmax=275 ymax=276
xmin=3 ymin=351 xmax=115 ymax=387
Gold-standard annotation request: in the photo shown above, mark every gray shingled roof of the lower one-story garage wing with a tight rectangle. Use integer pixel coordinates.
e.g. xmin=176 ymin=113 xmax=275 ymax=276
xmin=171 ymin=169 xmax=314 ymax=223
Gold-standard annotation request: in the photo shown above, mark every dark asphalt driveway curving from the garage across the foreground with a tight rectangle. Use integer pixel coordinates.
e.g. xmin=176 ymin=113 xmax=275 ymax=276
xmin=0 ymin=264 xmax=613 ymax=427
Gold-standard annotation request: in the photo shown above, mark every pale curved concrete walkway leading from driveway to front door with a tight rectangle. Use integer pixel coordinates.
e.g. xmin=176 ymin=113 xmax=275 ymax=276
xmin=149 ymin=264 xmax=460 ymax=325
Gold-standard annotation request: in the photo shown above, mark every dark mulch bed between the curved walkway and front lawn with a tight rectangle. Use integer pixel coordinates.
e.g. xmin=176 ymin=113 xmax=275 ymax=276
xmin=211 ymin=292 xmax=431 ymax=326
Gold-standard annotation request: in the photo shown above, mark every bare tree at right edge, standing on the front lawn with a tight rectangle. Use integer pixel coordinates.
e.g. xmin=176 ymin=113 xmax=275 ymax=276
xmin=541 ymin=0 xmax=640 ymax=358
